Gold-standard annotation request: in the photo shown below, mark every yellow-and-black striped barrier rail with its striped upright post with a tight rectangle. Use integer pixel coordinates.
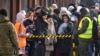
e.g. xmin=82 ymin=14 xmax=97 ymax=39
xmin=28 ymin=35 xmax=77 ymax=56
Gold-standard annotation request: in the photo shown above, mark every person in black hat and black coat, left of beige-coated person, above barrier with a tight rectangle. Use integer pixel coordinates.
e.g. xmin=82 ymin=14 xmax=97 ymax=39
xmin=35 ymin=10 xmax=48 ymax=35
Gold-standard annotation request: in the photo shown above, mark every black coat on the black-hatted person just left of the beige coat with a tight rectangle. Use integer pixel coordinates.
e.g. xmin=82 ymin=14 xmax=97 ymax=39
xmin=35 ymin=18 xmax=48 ymax=35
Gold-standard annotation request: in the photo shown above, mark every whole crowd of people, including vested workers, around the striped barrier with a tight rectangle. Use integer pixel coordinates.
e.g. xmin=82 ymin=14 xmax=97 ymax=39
xmin=0 ymin=3 xmax=100 ymax=56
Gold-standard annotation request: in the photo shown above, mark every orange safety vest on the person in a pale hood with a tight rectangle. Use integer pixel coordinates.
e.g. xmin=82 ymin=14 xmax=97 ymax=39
xmin=15 ymin=22 xmax=26 ymax=48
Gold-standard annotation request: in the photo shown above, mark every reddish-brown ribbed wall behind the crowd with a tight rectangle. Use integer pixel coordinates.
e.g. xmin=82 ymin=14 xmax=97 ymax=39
xmin=0 ymin=0 xmax=75 ymax=23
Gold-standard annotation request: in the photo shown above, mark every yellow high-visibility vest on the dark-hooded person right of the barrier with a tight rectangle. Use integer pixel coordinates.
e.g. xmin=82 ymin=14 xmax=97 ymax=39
xmin=78 ymin=17 xmax=93 ymax=39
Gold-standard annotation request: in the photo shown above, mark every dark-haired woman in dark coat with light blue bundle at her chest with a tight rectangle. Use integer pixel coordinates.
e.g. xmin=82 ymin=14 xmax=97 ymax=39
xmin=57 ymin=14 xmax=73 ymax=56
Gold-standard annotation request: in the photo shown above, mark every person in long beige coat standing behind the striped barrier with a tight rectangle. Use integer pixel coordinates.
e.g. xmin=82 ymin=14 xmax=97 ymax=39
xmin=45 ymin=15 xmax=57 ymax=56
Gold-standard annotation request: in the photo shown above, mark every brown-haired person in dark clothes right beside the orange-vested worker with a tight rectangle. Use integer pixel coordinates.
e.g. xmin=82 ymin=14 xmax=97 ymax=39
xmin=23 ymin=11 xmax=35 ymax=56
